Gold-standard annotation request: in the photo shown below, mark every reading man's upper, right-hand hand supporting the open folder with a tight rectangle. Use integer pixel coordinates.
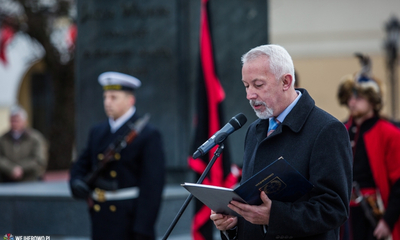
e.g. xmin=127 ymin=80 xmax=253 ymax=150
xmin=228 ymin=192 xmax=272 ymax=225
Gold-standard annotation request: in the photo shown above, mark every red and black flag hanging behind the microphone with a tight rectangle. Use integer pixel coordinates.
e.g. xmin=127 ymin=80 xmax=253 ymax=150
xmin=189 ymin=0 xmax=241 ymax=240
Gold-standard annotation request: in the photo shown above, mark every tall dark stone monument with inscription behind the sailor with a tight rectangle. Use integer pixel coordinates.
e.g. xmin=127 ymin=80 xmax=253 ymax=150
xmin=76 ymin=0 xmax=268 ymax=183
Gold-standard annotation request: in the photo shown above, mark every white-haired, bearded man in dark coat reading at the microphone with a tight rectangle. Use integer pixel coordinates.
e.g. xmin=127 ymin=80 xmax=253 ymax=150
xmin=210 ymin=45 xmax=352 ymax=240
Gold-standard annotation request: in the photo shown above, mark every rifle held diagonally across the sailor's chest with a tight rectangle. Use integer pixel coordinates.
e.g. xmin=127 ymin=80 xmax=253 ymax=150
xmin=85 ymin=114 xmax=150 ymax=189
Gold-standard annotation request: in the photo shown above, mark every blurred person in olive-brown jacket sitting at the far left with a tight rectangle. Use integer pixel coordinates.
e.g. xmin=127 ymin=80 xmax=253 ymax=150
xmin=0 ymin=106 xmax=47 ymax=182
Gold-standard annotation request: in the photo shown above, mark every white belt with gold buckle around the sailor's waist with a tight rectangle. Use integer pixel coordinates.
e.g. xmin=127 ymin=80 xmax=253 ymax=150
xmin=92 ymin=187 xmax=140 ymax=202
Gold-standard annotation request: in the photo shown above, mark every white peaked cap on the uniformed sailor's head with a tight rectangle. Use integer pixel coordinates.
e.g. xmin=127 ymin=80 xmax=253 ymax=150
xmin=99 ymin=72 xmax=142 ymax=91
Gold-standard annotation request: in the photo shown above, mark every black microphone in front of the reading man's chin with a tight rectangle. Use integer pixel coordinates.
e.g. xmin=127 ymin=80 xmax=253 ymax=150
xmin=193 ymin=113 xmax=247 ymax=159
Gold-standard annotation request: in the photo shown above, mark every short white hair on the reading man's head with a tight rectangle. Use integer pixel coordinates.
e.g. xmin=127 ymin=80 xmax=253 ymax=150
xmin=242 ymin=44 xmax=295 ymax=86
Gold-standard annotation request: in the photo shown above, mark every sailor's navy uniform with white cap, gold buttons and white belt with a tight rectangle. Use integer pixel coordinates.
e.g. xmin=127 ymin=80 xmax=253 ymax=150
xmin=70 ymin=72 xmax=165 ymax=240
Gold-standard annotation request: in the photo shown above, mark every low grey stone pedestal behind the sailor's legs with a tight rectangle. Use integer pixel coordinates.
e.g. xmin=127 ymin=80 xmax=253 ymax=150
xmin=0 ymin=181 xmax=193 ymax=240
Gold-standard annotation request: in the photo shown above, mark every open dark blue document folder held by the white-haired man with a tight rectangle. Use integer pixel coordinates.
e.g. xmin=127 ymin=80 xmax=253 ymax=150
xmin=182 ymin=157 xmax=314 ymax=216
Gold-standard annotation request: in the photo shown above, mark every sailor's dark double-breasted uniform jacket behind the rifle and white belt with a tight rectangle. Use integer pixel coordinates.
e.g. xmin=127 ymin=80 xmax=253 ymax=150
xmin=71 ymin=114 xmax=165 ymax=239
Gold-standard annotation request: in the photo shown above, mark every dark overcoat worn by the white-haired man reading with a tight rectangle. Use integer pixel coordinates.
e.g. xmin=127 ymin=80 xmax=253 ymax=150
xmin=233 ymin=89 xmax=352 ymax=240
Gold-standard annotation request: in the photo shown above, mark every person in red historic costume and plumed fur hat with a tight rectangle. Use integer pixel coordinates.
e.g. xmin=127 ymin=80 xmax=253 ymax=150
xmin=337 ymin=53 xmax=400 ymax=240
